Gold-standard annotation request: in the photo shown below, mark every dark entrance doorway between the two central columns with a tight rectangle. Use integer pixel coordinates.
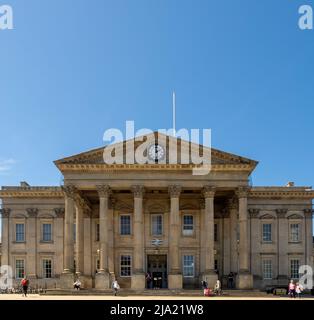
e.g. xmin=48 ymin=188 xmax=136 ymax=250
xmin=146 ymin=254 xmax=168 ymax=289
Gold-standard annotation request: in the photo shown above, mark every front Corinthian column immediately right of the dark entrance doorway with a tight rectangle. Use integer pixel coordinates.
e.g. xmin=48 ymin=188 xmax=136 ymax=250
xmin=168 ymin=185 xmax=182 ymax=289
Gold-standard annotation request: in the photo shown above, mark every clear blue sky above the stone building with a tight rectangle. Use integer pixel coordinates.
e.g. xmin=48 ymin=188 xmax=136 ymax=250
xmin=0 ymin=0 xmax=314 ymax=185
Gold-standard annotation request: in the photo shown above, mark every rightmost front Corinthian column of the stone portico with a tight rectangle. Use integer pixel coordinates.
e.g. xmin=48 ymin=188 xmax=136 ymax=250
xmin=237 ymin=187 xmax=253 ymax=289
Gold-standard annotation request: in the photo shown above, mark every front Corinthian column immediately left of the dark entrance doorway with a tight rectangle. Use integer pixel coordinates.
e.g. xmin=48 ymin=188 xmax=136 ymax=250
xmin=131 ymin=185 xmax=145 ymax=290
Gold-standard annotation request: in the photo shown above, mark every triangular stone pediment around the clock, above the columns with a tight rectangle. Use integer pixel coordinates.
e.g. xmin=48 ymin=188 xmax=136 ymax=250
xmin=55 ymin=132 xmax=258 ymax=171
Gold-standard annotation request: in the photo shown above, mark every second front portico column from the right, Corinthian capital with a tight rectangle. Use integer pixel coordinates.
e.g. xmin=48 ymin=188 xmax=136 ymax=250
xmin=201 ymin=186 xmax=217 ymax=288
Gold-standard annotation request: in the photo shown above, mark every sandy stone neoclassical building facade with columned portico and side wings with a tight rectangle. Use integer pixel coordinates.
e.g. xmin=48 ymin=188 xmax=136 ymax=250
xmin=0 ymin=133 xmax=314 ymax=290
